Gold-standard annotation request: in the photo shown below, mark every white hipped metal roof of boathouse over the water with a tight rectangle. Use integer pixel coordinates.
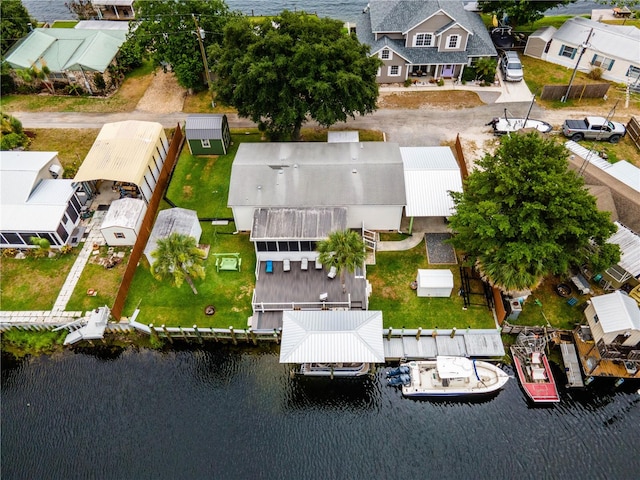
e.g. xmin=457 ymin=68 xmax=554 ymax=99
xmin=280 ymin=310 xmax=385 ymax=363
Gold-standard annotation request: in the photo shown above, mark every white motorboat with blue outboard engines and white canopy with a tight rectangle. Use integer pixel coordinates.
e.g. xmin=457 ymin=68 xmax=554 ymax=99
xmin=390 ymin=356 xmax=509 ymax=397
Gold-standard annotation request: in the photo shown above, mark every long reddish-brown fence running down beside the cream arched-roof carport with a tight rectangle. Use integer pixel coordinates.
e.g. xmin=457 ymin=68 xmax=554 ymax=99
xmin=111 ymin=125 xmax=184 ymax=320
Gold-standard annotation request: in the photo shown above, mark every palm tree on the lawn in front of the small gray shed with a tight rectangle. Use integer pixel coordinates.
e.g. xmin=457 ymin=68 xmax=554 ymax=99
xmin=151 ymin=233 xmax=205 ymax=295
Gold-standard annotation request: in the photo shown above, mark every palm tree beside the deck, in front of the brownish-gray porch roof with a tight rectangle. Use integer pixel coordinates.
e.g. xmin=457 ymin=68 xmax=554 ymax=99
xmin=316 ymin=230 xmax=367 ymax=291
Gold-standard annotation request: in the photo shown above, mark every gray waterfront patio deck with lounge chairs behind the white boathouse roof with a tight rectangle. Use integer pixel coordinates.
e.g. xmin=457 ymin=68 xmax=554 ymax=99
xmin=253 ymin=261 xmax=367 ymax=318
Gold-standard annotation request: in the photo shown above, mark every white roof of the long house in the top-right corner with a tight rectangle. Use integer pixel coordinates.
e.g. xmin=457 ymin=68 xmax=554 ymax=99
xmin=553 ymin=17 xmax=640 ymax=62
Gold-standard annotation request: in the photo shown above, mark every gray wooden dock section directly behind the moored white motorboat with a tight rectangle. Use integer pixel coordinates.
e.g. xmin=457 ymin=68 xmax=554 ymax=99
xmin=384 ymin=329 xmax=505 ymax=361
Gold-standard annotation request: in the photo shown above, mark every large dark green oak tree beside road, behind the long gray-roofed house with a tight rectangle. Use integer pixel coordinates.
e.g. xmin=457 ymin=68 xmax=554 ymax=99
xmin=214 ymin=11 xmax=380 ymax=140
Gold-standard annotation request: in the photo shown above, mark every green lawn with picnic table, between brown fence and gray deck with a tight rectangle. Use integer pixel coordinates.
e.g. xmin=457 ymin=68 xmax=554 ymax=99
xmin=123 ymin=222 xmax=255 ymax=328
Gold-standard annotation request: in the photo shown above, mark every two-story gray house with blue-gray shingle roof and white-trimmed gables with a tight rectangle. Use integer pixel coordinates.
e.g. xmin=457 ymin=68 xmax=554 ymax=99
xmin=357 ymin=0 xmax=497 ymax=83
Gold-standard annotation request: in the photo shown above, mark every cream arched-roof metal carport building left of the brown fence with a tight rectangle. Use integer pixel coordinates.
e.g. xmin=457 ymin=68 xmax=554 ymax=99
xmin=74 ymin=120 xmax=169 ymax=204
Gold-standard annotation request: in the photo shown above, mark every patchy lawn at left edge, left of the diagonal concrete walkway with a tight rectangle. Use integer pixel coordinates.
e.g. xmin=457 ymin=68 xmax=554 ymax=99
xmin=0 ymin=253 xmax=78 ymax=310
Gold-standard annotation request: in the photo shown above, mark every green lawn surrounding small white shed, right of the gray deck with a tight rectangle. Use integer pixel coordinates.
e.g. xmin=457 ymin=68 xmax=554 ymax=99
xmin=367 ymin=242 xmax=495 ymax=329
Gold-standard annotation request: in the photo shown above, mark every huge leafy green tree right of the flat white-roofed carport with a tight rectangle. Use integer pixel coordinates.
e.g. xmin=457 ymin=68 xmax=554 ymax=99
xmin=450 ymin=132 xmax=620 ymax=291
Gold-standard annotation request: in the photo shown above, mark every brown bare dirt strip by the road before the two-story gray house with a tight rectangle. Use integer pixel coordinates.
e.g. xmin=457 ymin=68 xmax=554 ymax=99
xmin=378 ymin=90 xmax=484 ymax=110
